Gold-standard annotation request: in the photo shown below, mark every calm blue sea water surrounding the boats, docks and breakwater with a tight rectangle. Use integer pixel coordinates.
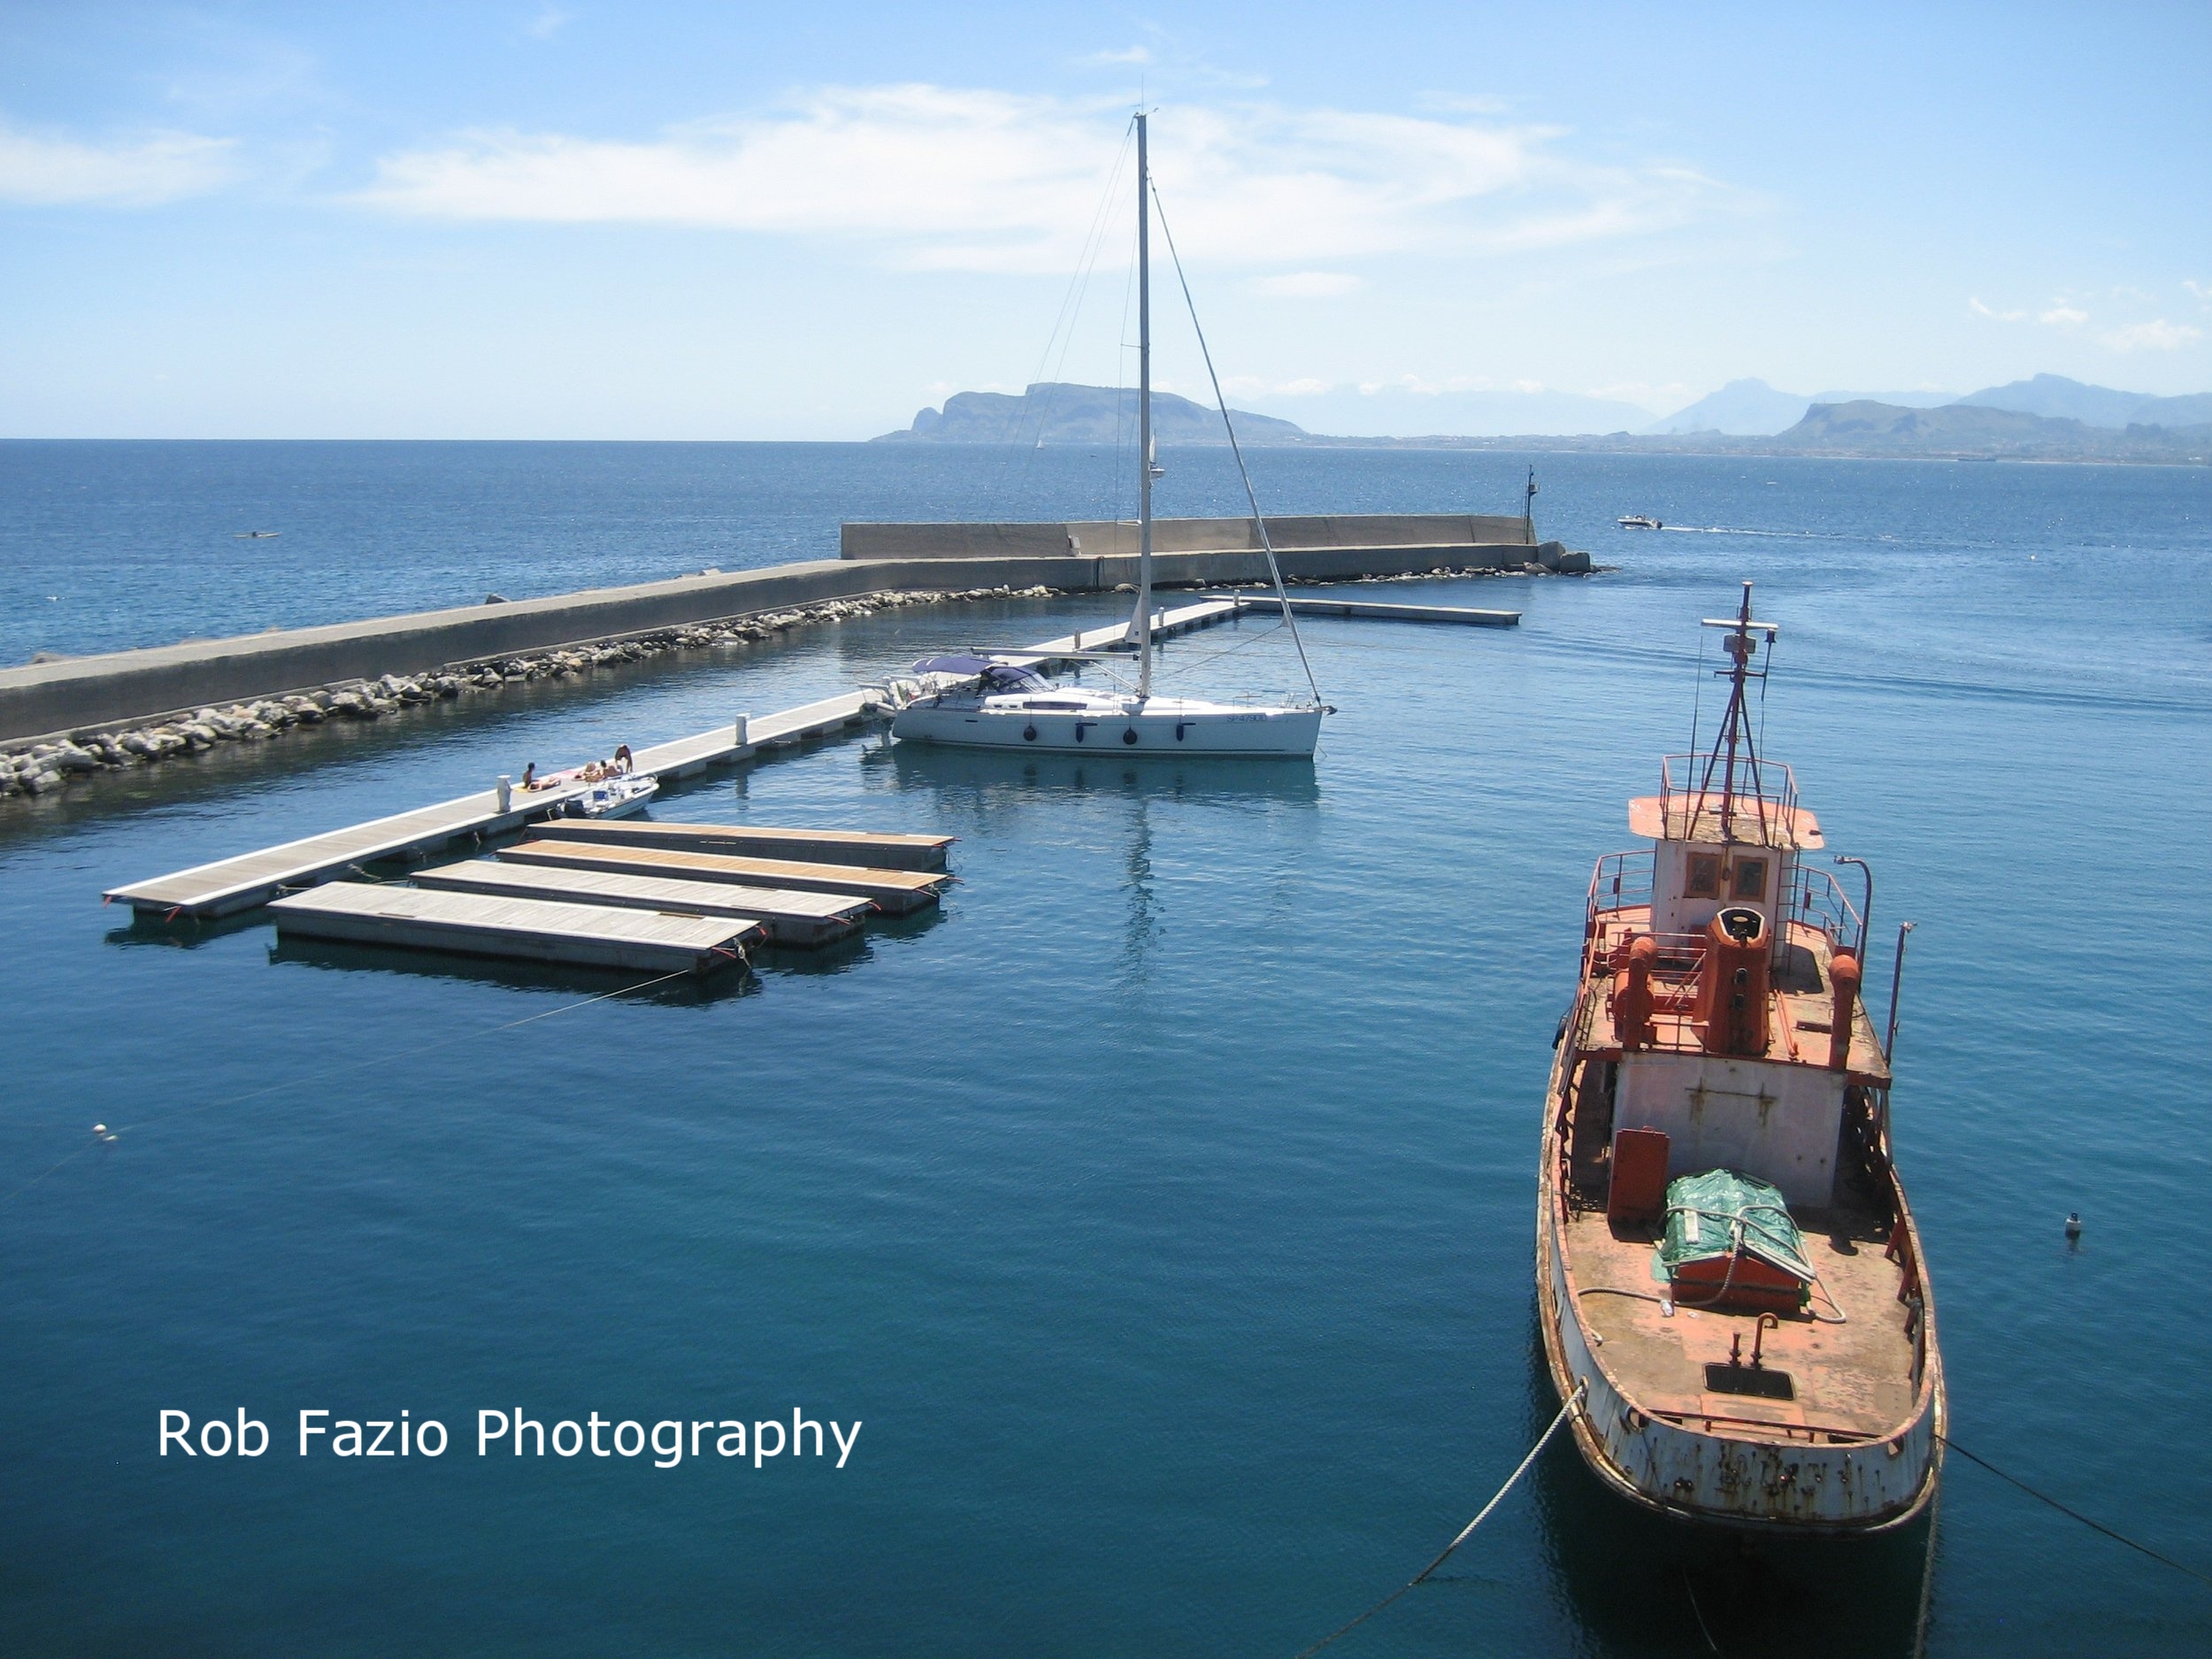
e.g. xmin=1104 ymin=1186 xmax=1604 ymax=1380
xmin=0 ymin=442 xmax=2212 ymax=1659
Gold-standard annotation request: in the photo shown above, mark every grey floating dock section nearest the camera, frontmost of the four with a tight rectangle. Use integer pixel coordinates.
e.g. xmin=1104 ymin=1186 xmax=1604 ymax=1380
xmin=270 ymin=880 xmax=761 ymax=973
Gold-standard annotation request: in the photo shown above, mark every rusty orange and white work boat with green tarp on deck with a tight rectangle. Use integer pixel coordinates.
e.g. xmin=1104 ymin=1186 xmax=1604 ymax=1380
xmin=1538 ymin=582 xmax=1945 ymax=1535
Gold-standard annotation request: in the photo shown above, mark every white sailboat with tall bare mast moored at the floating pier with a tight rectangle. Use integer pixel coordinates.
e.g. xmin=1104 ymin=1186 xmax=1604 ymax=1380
xmin=892 ymin=111 xmax=1330 ymax=761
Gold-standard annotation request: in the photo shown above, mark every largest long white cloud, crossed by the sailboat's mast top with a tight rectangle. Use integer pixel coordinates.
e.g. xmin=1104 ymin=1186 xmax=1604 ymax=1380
xmin=358 ymin=87 xmax=1743 ymax=273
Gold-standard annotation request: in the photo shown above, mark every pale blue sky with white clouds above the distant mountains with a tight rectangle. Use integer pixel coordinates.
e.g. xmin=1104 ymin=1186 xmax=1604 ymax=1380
xmin=0 ymin=0 xmax=2212 ymax=441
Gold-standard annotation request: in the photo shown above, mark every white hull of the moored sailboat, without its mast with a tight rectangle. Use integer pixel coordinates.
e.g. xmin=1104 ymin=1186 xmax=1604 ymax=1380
xmin=892 ymin=690 xmax=1321 ymax=761
